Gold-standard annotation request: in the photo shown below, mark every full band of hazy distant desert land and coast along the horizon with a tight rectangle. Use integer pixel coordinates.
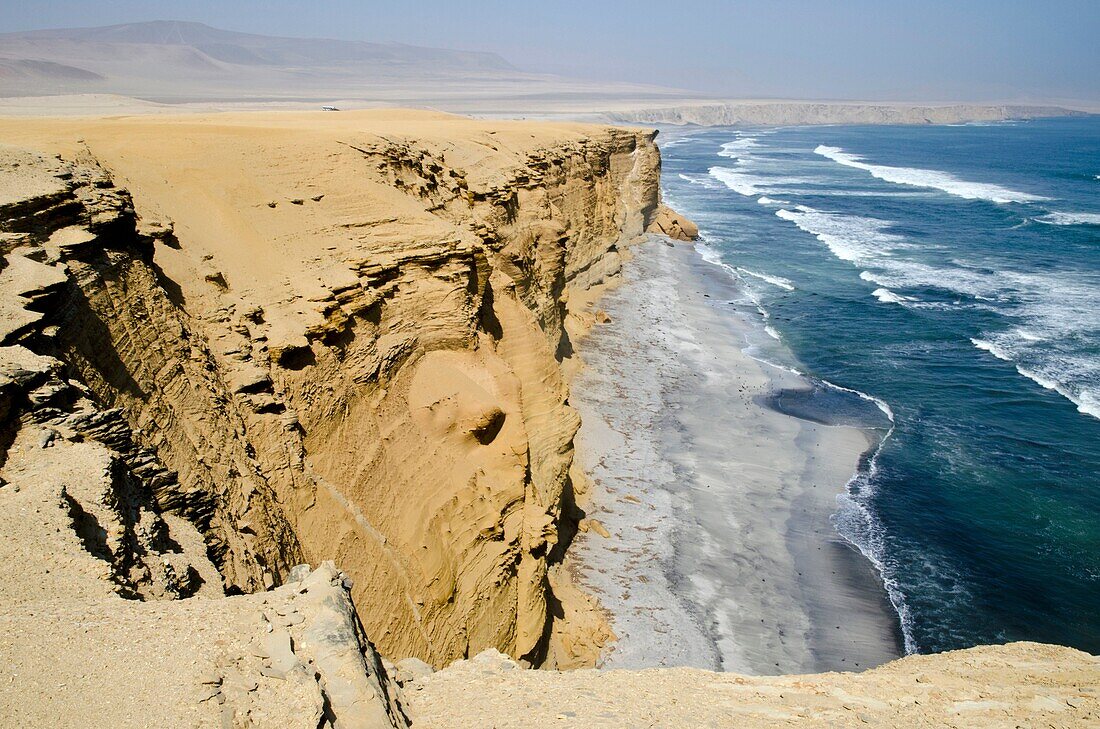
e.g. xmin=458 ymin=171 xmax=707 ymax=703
xmin=0 ymin=21 xmax=1082 ymax=117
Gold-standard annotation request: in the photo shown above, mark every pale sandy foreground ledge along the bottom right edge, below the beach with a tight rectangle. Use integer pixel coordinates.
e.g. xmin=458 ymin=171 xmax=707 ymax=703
xmin=405 ymin=643 xmax=1100 ymax=729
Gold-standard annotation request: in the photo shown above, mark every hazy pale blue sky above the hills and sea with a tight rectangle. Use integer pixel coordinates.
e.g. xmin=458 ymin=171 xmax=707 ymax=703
xmin=0 ymin=0 xmax=1100 ymax=101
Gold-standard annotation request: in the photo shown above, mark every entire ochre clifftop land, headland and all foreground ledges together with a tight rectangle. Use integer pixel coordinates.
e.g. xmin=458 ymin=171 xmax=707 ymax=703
xmin=0 ymin=105 xmax=1100 ymax=728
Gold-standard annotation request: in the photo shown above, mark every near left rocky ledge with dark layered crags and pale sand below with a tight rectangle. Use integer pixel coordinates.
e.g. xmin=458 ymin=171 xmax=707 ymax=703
xmin=0 ymin=148 xmax=405 ymax=728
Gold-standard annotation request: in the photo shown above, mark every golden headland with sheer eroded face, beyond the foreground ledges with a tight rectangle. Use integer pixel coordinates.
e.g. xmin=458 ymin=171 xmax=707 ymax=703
xmin=3 ymin=112 xmax=659 ymax=665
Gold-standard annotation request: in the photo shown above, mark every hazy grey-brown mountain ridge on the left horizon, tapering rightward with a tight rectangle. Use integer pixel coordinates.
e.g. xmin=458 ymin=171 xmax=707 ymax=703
xmin=0 ymin=21 xmax=547 ymax=100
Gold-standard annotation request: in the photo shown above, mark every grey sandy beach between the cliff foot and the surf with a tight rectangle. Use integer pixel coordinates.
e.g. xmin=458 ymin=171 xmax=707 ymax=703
xmin=570 ymin=239 xmax=901 ymax=674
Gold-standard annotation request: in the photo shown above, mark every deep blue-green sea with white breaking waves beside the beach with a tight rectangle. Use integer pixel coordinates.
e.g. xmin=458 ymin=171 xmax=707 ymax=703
xmin=660 ymin=118 xmax=1100 ymax=653
